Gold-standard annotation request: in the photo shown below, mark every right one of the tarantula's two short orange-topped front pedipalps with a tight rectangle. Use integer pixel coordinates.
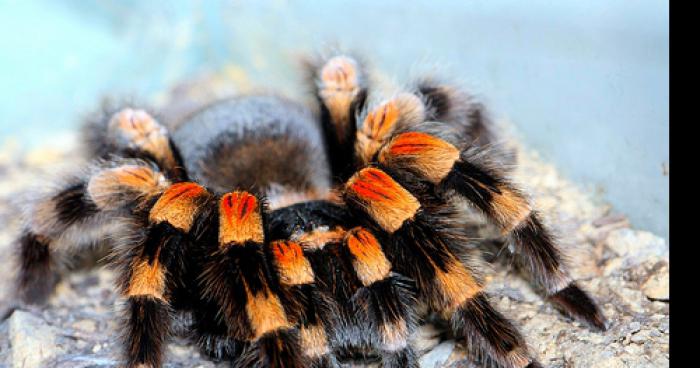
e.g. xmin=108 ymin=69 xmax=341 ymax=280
xmin=345 ymin=227 xmax=418 ymax=368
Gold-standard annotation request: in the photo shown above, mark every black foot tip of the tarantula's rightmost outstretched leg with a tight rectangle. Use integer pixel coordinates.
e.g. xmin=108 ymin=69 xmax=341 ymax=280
xmin=549 ymin=282 xmax=608 ymax=331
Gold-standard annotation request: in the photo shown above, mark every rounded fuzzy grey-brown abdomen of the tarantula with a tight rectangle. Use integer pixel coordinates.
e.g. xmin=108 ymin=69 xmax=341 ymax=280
xmin=172 ymin=96 xmax=330 ymax=198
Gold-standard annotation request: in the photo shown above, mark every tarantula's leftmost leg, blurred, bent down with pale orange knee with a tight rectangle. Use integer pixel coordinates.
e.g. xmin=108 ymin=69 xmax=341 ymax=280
xmin=17 ymin=163 xmax=165 ymax=304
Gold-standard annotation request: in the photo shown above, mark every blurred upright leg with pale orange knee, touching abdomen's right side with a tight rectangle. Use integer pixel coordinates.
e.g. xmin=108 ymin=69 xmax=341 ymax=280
xmin=315 ymin=55 xmax=367 ymax=180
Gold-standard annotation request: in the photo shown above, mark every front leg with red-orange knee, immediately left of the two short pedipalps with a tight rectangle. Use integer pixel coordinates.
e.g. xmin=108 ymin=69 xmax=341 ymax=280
xmin=200 ymin=192 xmax=304 ymax=367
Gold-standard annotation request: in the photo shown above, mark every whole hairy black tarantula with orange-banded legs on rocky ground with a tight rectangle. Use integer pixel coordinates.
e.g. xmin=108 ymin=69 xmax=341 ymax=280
xmin=12 ymin=54 xmax=606 ymax=368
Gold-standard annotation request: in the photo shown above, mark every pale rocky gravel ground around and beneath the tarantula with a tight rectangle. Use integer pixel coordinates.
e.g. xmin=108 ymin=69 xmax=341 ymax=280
xmin=0 ymin=77 xmax=669 ymax=368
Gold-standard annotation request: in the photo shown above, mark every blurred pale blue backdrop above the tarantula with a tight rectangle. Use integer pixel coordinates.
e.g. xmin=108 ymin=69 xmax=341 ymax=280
xmin=0 ymin=0 xmax=669 ymax=237
